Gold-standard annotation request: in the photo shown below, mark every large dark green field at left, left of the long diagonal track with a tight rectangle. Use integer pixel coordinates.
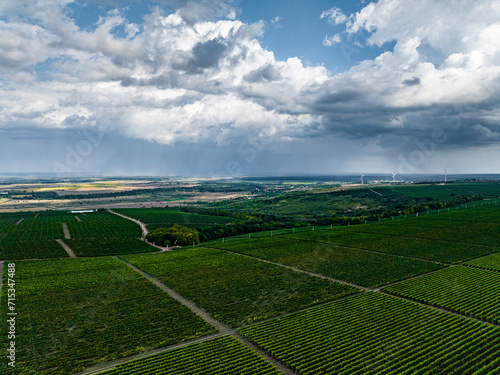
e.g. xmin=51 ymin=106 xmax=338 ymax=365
xmin=0 ymin=258 xmax=215 ymax=374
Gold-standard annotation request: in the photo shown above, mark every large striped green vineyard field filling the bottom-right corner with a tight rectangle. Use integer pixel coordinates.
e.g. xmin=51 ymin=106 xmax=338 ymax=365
xmin=240 ymin=293 xmax=500 ymax=375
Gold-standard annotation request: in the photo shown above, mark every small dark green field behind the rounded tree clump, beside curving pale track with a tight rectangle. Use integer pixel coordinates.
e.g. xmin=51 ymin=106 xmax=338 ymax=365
xmin=114 ymin=208 xmax=235 ymax=230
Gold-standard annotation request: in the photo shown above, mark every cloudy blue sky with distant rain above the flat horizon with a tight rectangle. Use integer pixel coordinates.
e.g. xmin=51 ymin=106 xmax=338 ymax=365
xmin=0 ymin=0 xmax=500 ymax=177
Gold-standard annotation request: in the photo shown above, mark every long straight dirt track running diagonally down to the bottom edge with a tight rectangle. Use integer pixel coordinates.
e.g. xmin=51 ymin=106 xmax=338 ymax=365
xmin=113 ymin=256 xmax=295 ymax=375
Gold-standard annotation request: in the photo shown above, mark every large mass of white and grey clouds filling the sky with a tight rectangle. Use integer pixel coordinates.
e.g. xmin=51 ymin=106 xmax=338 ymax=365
xmin=0 ymin=0 xmax=500 ymax=169
